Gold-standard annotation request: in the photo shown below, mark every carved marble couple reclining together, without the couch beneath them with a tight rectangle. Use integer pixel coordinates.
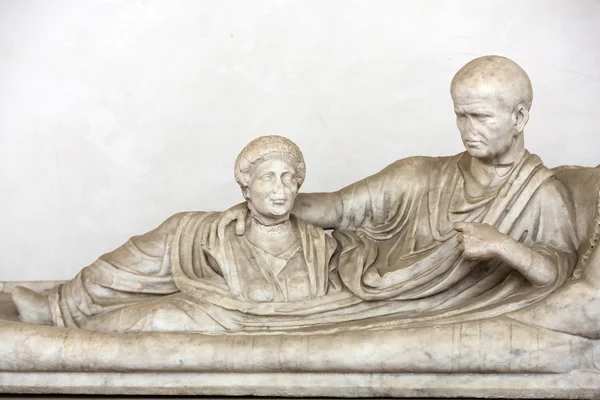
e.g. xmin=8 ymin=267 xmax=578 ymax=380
xmin=13 ymin=56 xmax=577 ymax=333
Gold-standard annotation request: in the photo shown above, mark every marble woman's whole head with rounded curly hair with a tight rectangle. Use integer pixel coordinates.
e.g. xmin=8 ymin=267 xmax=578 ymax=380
xmin=235 ymin=136 xmax=306 ymax=222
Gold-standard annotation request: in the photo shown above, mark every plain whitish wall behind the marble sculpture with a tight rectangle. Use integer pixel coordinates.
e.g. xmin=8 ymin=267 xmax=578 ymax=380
xmin=0 ymin=0 xmax=600 ymax=281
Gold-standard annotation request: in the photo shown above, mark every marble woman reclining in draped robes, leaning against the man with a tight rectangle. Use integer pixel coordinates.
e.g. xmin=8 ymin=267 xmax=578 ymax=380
xmin=13 ymin=136 xmax=341 ymax=332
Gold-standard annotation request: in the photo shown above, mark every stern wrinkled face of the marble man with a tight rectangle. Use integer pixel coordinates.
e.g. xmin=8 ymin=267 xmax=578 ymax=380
xmin=452 ymin=82 xmax=515 ymax=162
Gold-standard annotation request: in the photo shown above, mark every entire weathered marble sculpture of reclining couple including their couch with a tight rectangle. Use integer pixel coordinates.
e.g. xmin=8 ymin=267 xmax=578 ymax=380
xmin=0 ymin=57 xmax=600 ymax=398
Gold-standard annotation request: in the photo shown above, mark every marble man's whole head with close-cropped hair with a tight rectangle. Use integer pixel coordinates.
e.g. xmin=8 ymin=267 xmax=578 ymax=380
xmin=450 ymin=56 xmax=533 ymax=165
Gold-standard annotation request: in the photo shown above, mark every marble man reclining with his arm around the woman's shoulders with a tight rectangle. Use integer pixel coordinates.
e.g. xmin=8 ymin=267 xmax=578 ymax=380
xmin=213 ymin=56 xmax=577 ymax=324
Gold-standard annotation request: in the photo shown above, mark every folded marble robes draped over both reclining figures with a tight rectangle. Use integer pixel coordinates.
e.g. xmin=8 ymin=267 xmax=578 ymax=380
xmin=45 ymin=153 xmax=576 ymax=333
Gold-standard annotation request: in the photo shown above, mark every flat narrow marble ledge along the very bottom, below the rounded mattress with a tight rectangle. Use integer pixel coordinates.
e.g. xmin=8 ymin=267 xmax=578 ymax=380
xmin=0 ymin=371 xmax=600 ymax=399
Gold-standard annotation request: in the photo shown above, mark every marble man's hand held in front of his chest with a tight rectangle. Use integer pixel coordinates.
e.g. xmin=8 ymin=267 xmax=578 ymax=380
xmin=454 ymin=222 xmax=510 ymax=261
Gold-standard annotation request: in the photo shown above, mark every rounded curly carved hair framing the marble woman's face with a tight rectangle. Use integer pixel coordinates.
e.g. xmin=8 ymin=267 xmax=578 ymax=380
xmin=234 ymin=135 xmax=306 ymax=188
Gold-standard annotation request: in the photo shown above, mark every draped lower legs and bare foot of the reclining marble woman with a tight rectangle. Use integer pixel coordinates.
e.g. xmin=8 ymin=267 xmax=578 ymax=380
xmin=12 ymin=213 xmax=190 ymax=327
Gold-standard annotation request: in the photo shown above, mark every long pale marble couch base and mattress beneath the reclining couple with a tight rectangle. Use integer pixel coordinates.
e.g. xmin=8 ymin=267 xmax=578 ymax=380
xmin=0 ymin=286 xmax=600 ymax=399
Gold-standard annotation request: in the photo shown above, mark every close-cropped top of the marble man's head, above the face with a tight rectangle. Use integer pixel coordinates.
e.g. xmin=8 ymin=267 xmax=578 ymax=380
xmin=450 ymin=56 xmax=533 ymax=110
